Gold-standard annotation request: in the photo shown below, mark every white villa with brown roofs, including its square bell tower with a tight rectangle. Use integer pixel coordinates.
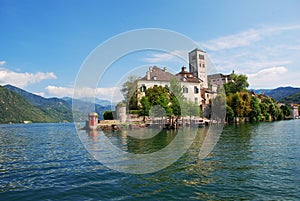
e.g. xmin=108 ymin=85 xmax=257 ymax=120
xmin=137 ymin=49 xmax=209 ymax=106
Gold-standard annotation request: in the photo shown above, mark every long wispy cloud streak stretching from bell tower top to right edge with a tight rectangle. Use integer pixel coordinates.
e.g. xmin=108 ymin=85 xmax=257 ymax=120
xmin=202 ymin=25 xmax=300 ymax=51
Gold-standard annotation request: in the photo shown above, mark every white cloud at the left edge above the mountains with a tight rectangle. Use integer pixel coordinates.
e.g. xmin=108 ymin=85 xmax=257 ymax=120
xmin=0 ymin=68 xmax=57 ymax=88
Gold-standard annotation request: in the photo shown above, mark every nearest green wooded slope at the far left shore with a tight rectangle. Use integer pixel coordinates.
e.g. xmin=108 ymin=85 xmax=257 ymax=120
xmin=0 ymin=86 xmax=55 ymax=123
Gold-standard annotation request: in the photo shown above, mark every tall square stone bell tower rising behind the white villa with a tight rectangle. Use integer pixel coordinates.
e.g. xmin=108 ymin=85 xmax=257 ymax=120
xmin=189 ymin=48 xmax=208 ymax=88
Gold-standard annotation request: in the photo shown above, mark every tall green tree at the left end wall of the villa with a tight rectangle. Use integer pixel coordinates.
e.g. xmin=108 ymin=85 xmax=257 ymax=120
xmin=121 ymin=76 xmax=138 ymax=110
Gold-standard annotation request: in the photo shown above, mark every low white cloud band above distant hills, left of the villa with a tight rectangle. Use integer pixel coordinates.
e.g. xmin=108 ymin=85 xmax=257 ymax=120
xmin=46 ymin=86 xmax=123 ymax=102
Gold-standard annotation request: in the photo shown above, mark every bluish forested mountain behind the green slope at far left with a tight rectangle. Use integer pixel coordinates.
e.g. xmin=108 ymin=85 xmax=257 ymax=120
xmin=4 ymin=85 xmax=73 ymax=122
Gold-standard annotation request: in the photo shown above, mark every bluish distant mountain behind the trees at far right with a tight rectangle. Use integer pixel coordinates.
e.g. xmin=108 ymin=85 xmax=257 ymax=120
xmin=253 ymin=87 xmax=300 ymax=101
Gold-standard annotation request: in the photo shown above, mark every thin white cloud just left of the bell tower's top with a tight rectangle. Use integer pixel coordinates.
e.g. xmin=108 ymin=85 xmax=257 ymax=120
xmin=143 ymin=50 xmax=187 ymax=63
